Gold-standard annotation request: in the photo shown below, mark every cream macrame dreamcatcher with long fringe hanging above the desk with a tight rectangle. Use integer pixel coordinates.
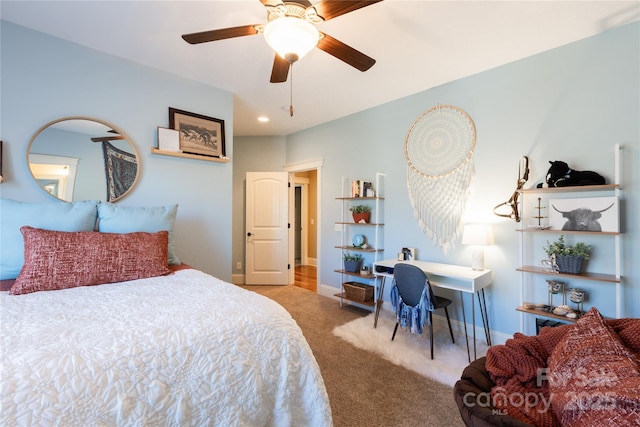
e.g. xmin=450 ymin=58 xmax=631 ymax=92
xmin=404 ymin=105 xmax=476 ymax=253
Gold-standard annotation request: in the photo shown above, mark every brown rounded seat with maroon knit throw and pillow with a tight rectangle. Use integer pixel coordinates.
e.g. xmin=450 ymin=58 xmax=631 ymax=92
xmin=454 ymin=308 xmax=640 ymax=427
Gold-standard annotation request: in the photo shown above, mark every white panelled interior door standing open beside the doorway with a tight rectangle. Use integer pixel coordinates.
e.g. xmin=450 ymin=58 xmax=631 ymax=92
xmin=245 ymin=172 xmax=290 ymax=285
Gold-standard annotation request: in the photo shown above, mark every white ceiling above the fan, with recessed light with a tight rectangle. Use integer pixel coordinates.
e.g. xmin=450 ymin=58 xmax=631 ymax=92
xmin=0 ymin=0 xmax=640 ymax=136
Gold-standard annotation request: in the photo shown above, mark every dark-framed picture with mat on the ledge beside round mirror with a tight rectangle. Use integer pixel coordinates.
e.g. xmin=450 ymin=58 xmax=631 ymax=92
xmin=169 ymin=107 xmax=226 ymax=158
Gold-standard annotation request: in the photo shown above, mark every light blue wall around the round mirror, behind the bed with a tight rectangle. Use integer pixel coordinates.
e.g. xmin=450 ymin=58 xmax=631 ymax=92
xmin=0 ymin=21 xmax=233 ymax=280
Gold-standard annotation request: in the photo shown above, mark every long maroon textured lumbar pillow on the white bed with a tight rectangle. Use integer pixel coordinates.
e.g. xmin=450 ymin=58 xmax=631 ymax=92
xmin=9 ymin=226 xmax=171 ymax=295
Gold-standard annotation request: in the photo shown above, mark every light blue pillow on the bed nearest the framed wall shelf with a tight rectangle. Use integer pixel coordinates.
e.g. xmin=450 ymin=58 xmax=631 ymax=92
xmin=98 ymin=203 xmax=180 ymax=265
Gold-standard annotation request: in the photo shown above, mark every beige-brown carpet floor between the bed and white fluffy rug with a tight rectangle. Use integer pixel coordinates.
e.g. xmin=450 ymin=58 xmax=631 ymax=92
xmin=240 ymin=286 xmax=464 ymax=427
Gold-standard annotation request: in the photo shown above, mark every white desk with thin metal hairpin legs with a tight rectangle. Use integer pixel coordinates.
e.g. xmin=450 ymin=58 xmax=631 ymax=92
xmin=373 ymin=259 xmax=493 ymax=362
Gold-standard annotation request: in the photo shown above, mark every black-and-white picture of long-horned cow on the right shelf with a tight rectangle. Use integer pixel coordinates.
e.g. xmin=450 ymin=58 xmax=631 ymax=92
xmin=549 ymin=196 xmax=620 ymax=233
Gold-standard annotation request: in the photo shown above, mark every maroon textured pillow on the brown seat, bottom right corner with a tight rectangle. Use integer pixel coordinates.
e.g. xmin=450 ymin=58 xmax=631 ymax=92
xmin=549 ymin=308 xmax=640 ymax=427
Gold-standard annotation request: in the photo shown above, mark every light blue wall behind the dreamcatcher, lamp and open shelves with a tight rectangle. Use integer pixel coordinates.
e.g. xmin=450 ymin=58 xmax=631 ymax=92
xmin=241 ymin=23 xmax=640 ymax=334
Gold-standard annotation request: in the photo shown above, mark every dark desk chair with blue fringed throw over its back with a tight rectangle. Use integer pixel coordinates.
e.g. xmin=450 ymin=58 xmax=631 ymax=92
xmin=391 ymin=263 xmax=455 ymax=359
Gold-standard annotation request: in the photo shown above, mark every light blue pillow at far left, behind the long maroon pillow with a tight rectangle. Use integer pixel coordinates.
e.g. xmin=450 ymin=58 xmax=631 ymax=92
xmin=0 ymin=199 xmax=100 ymax=280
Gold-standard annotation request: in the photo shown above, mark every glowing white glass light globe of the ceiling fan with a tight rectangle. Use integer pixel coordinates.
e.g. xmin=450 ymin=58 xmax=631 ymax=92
xmin=264 ymin=16 xmax=320 ymax=62
